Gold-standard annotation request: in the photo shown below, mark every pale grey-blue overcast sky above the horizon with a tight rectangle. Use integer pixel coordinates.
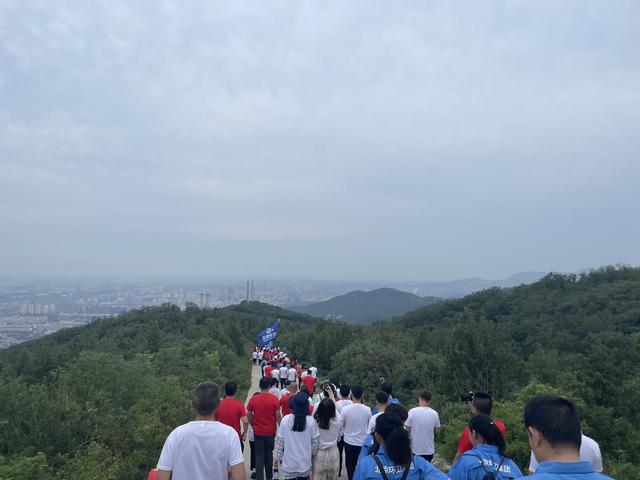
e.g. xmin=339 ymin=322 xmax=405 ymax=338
xmin=0 ymin=0 xmax=640 ymax=280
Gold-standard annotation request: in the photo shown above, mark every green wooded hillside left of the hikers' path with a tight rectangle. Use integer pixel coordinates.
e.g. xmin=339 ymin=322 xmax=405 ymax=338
xmin=0 ymin=302 xmax=312 ymax=480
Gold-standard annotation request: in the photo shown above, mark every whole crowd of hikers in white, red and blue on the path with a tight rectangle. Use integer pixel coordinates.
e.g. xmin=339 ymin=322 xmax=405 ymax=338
xmin=149 ymin=347 xmax=609 ymax=480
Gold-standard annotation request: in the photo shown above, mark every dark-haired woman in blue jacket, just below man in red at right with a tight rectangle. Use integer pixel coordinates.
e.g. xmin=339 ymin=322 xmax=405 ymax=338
xmin=449 ymin=413 xmax=522 ymax=480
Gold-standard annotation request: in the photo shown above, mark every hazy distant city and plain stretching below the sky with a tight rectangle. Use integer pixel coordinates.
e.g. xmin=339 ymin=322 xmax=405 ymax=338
xmin=0 ymin=273 xmax=542 ymax=348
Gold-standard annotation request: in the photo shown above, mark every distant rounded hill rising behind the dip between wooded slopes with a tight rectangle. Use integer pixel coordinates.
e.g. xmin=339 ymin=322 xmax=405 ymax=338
xmin=289 ymin=288 xmax=440 ymax=324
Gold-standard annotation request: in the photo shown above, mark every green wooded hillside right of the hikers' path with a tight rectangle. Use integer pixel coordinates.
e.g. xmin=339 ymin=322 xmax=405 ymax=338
xmin=282 ymin=267 xmax=640 ymax=480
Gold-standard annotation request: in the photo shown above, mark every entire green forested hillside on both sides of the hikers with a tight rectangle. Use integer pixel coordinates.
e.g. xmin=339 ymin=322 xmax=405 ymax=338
xmin=0 ymin=267 xmax=640 ymax=480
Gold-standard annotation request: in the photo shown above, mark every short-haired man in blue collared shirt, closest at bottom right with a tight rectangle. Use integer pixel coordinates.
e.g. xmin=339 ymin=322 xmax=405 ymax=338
xmin=524 ymin=395 xmax=611 ymax=480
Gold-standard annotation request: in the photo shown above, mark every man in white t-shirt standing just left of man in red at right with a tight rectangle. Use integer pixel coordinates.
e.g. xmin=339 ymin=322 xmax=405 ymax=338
xmin=405 ymin=392 xmax=440 ymax=463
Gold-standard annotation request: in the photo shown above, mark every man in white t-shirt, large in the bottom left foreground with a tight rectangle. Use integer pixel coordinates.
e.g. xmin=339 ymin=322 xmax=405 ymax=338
xmin=157 ymin=382 xmax=246 ymax=480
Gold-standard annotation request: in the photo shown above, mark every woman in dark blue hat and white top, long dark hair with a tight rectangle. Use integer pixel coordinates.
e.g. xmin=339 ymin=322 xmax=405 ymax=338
xmin=273 ymin=392 xmax=320 ymax=480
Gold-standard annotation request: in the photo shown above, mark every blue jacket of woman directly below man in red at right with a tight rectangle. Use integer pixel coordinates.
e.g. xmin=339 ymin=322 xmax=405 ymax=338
xmin=449 ymin=445 xmax=522 ymax=480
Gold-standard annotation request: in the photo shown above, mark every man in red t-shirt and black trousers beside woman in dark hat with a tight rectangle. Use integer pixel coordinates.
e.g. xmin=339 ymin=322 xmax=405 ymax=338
xmin=247 ymin=377 xmax=282 ymax=480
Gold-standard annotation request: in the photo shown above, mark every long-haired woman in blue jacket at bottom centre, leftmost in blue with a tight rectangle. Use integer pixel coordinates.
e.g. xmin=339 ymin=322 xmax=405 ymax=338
xmin=353 ymin=412 xmax=448 ymax=480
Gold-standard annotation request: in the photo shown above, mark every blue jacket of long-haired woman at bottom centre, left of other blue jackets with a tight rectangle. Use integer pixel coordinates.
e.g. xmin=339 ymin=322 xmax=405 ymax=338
xmin=353 ymin=445 xmax=449 ymax=480
